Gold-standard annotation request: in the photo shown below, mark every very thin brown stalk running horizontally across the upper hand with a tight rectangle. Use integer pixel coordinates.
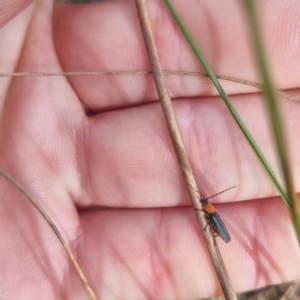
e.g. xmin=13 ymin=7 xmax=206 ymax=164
xmin=0 ymin=70 xmax=300 ymax=103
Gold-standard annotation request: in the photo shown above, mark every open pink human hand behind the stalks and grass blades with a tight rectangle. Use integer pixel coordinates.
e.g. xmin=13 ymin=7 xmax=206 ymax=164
xmin=0 ymin=0 xmax=300 ymax=300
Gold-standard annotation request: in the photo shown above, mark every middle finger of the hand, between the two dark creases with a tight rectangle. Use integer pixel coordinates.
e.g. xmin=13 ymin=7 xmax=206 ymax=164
xmin=81 ymin=91 xmax=300 ymax=207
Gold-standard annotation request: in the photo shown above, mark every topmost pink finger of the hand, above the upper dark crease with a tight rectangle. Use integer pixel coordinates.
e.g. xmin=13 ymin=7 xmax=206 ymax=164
xmin=54 ymin=0 xmax=300 ymax=111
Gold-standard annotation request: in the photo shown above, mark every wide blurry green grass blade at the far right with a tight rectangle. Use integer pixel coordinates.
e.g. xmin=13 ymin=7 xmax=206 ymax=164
xmin=244 ymin=0 xmax=300 ymax=244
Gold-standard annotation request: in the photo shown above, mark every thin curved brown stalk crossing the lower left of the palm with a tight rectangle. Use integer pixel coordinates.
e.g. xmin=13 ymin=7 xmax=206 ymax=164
xmin=0 ymin=169 xmax=97 ymax=300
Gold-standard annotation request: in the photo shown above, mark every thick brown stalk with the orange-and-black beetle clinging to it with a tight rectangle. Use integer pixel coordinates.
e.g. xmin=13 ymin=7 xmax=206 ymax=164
xmin=135 ymin=0 xmax=236 ymax=299
